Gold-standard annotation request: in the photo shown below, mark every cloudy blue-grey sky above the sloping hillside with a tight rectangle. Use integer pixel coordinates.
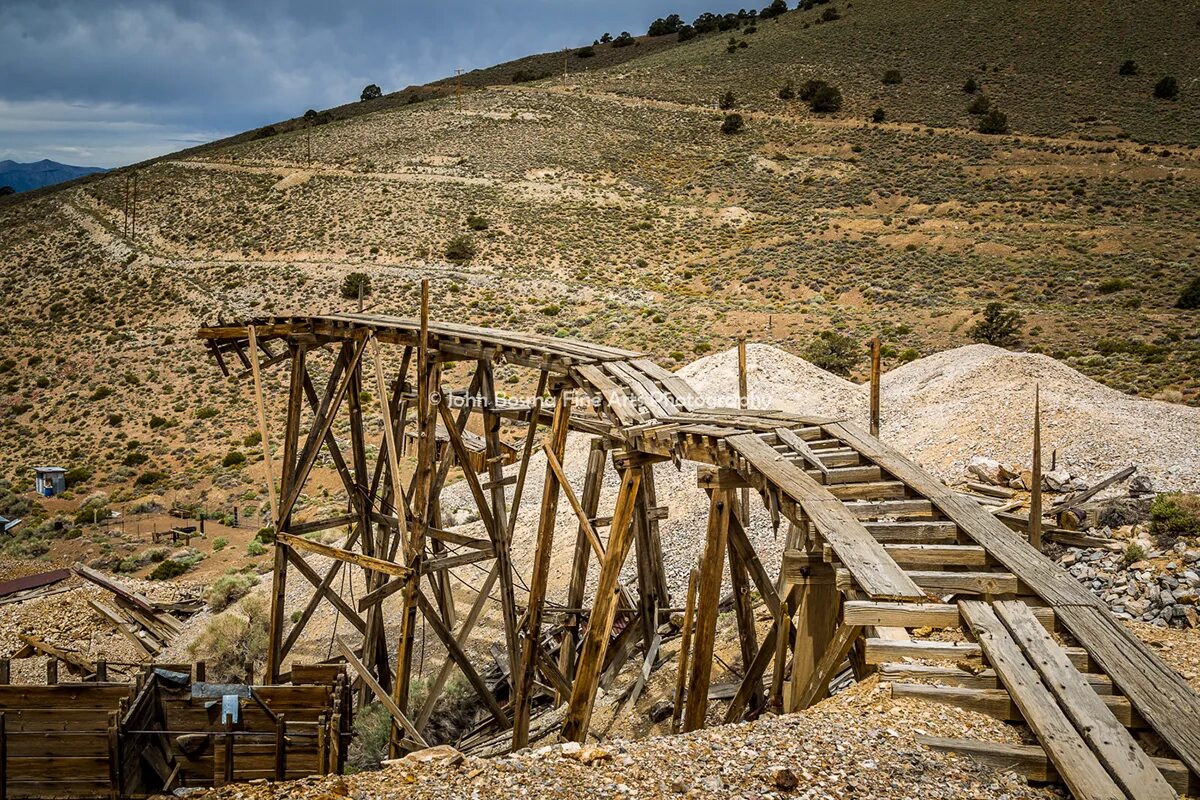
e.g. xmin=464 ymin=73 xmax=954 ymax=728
xmin=0 ymin=0 xmax=715 ymax=167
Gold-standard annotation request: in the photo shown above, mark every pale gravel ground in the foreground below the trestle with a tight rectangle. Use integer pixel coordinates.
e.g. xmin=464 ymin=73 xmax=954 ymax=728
xmin=189 ymin=680 xmax=1062 ymax=800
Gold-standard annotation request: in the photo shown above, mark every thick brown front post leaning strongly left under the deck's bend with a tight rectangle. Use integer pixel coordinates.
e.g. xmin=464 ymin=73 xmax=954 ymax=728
xmin=563 ymin=467 xmax=642 ymax=741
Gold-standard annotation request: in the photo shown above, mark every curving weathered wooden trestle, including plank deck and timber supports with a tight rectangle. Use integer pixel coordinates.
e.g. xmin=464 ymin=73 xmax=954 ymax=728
xmin=199 ymin=309 xmax=1200 ymax=798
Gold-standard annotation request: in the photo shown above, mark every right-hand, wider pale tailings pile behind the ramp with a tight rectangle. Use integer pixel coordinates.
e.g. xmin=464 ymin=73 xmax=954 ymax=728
xmin=881 ymin=344 xmax=1200 ymax=491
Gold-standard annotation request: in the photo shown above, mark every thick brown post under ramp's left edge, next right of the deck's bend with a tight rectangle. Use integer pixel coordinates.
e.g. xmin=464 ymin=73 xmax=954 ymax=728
xmin=683 ymin=489 xmax=733 ymax=732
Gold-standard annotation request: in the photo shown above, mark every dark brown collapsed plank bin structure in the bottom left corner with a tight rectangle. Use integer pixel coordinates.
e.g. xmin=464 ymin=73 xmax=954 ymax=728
xmin=0 ymin=663 xmax=352 ymax=800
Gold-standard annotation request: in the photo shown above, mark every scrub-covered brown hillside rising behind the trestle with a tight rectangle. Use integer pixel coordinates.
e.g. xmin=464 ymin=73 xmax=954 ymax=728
xmin=0 ymin=0 xmax=1200 ymax=525
